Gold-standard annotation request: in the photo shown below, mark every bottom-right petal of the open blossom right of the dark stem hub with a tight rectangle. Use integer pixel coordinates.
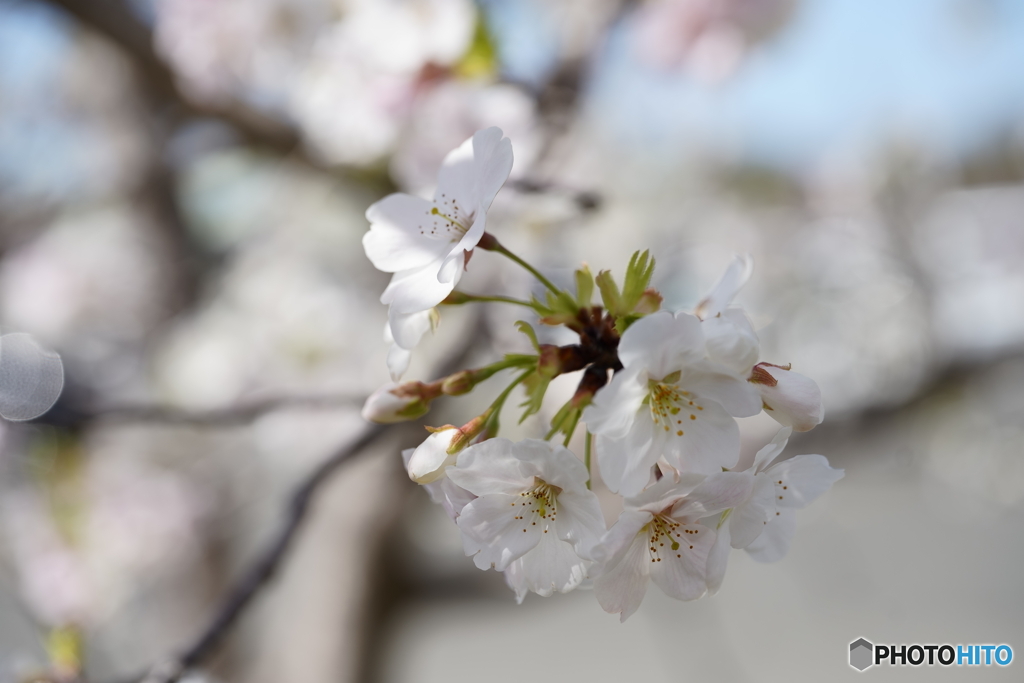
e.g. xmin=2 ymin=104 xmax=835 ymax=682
xmin=664 ymin=397 xmax=739 ymax=474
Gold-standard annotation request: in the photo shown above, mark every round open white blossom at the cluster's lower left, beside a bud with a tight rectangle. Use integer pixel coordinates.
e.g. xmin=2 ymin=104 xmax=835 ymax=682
xmin=447 ymin=438 xmax=604 ymax=602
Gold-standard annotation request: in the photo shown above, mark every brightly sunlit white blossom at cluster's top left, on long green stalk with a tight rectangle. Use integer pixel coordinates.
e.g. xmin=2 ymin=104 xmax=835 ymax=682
xmin=362 ymin=128 xmax=512 ymax=374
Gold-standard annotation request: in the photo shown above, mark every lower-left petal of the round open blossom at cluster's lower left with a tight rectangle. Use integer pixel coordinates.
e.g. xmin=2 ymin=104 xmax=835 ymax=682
xmin=457 ymin=494 xmax=544 ymax=571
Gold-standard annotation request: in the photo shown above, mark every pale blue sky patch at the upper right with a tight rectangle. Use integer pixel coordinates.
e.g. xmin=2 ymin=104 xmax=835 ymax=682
xmin=577 ymin=0 xmax=1024 ymax=166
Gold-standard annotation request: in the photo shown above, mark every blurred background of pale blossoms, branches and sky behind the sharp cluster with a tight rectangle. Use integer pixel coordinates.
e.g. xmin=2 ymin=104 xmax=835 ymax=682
xmin=0 ymin=0 xmax=1024 ymax=683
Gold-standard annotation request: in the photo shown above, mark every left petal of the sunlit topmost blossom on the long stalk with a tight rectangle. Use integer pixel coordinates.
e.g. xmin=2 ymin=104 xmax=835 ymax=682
xmin=362 ymin=193 xmax=452 ymax=272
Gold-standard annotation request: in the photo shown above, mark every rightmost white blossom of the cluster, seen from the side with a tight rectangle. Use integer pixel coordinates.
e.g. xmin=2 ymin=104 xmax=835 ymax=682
xmin=708 ymin=427 xmax=844 ymax=593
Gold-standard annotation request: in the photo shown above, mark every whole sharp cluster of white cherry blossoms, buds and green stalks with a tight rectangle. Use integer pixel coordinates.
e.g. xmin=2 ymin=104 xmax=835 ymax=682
xmin=364 ymin=128 xmax=843 ymax=620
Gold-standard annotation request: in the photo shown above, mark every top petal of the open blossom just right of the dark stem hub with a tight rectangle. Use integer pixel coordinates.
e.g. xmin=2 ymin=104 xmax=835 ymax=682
xmin=618 ymin=310 xmax=705 ymax=380
